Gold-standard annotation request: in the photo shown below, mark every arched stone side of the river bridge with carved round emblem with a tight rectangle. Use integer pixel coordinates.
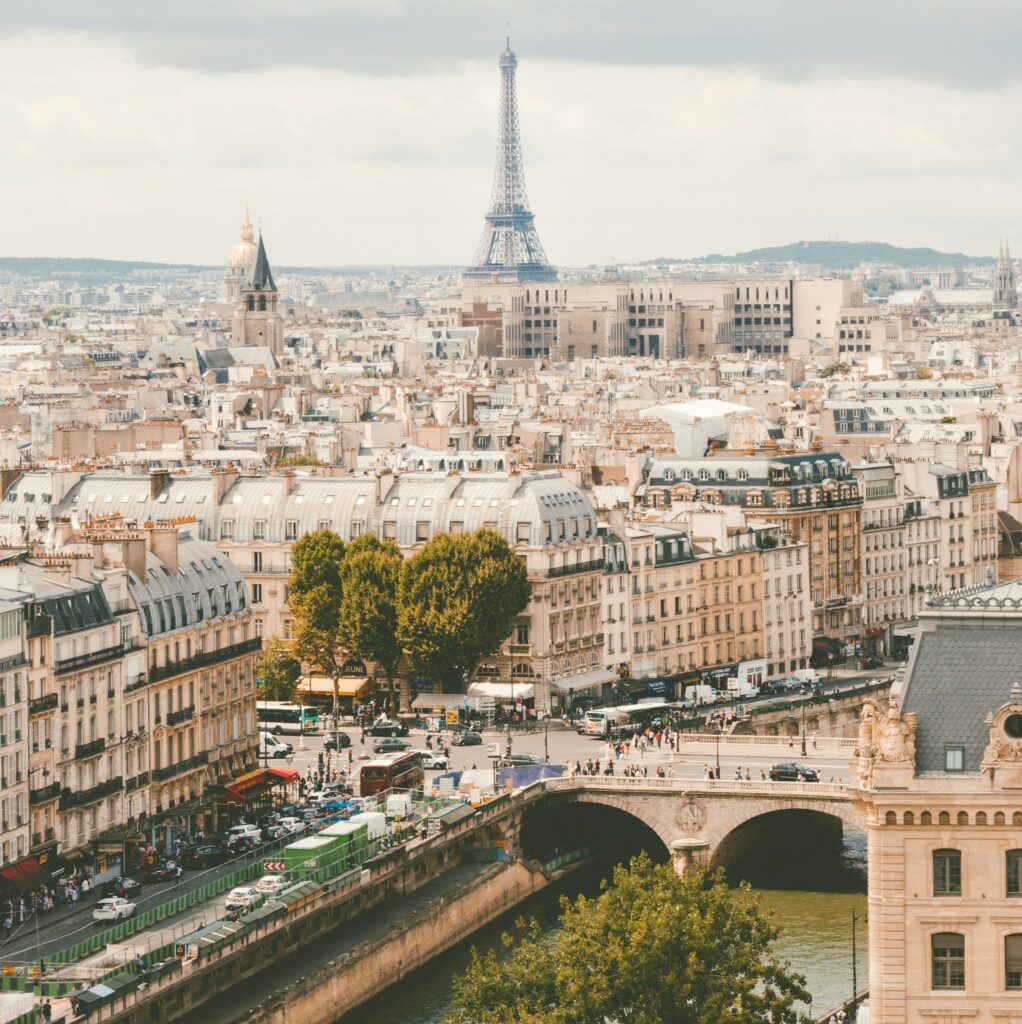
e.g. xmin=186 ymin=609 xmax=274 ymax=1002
xmin=523 ymin=775 xmax=864 ymax=871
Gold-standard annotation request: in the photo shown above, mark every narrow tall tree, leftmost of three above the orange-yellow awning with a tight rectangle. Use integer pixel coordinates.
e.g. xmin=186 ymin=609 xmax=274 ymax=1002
xmin=288 ymin=529 xmax=347 ymax=715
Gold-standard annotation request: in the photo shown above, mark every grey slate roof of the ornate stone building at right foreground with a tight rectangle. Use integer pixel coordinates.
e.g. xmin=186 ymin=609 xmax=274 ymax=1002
xmin=901 ymin=616 xmax=1022 ymax=772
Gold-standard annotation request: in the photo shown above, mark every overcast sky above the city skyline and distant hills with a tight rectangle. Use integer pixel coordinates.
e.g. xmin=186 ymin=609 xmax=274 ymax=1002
xmin=0 ymin=0 xmax=1022 ymax=265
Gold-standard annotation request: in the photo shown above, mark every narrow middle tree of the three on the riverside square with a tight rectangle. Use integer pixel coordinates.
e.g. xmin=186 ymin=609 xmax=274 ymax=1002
xmin=340 ymin=534 xmax=404 ymax=713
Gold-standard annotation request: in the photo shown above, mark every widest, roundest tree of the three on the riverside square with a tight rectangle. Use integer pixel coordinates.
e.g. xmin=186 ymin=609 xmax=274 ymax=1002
xmin=397 ymin=529 xmax=531 ymax=692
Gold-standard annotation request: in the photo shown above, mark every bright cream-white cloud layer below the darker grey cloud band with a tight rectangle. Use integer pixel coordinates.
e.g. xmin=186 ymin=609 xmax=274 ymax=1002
xmin=0 ymin=32 xmax=1022 ymax=264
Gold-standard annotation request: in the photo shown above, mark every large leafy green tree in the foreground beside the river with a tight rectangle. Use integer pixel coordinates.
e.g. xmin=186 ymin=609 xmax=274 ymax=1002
xmin=446 ymin=854 xmax=811 ymax=1024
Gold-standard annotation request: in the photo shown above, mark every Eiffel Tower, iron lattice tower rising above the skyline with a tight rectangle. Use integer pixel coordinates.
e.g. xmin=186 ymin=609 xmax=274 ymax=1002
xmin=464 ymin=40 xmax=557 ymax=283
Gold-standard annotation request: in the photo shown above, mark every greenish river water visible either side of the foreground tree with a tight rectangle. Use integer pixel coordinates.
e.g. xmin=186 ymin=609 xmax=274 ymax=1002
xmin=342 ymin=831 xmax=868 ymax=1024
